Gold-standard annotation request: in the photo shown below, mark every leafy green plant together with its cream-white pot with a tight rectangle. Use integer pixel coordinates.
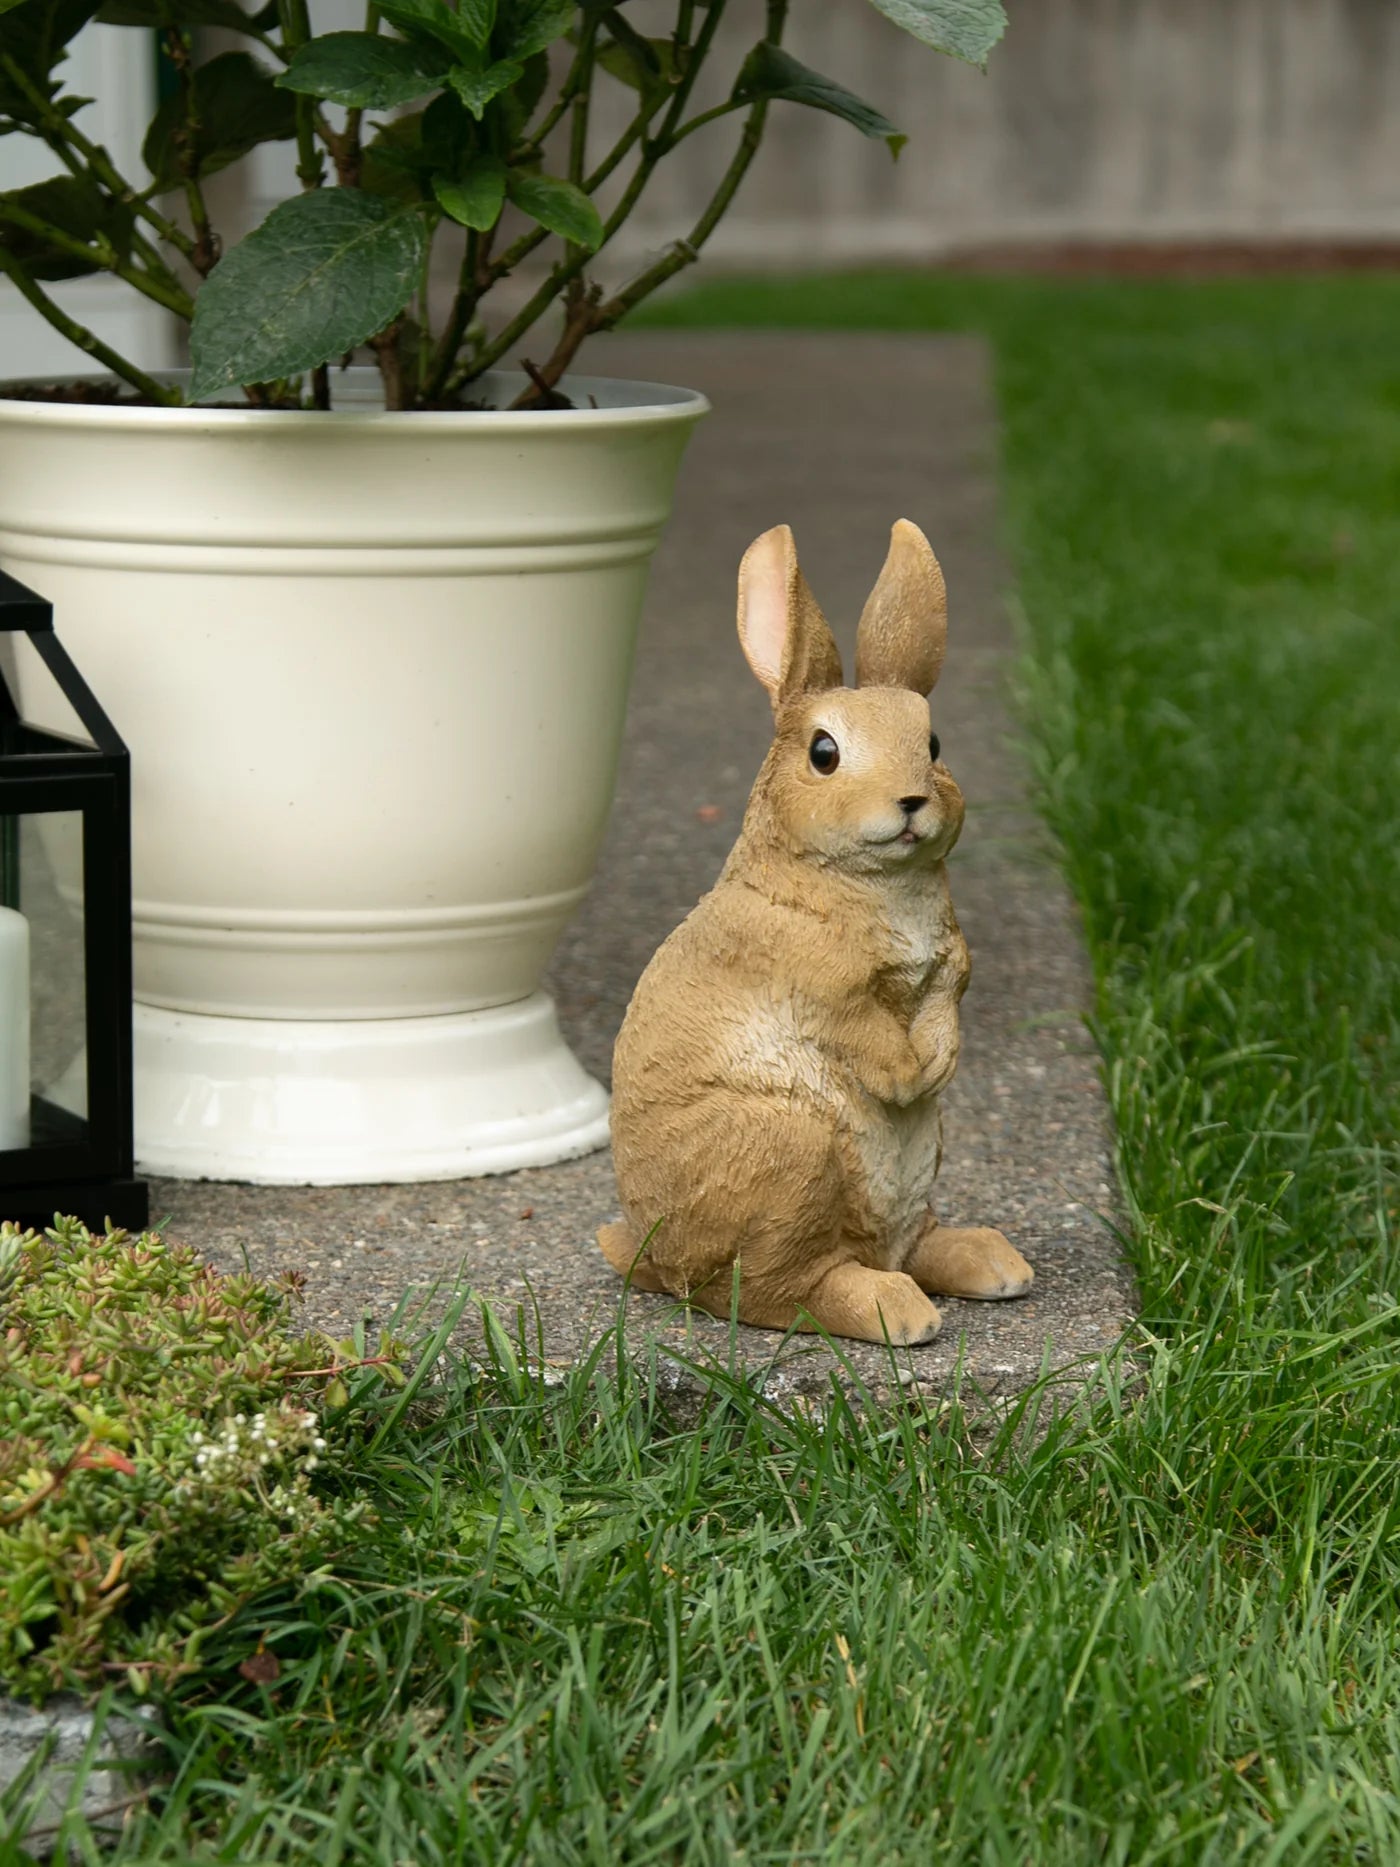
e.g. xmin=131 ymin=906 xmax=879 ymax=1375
xmin=0 ymin=0 xmax=1002 ymax=1182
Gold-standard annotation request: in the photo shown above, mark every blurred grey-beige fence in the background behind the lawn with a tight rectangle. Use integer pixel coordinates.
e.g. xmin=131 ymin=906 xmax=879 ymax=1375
xmin=604 ymin=0 xmax=1400 ymax=265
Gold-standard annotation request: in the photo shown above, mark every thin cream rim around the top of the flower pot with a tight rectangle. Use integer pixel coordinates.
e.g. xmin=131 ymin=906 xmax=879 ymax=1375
xmin=0 ymin=366 xmax=711 ymax=435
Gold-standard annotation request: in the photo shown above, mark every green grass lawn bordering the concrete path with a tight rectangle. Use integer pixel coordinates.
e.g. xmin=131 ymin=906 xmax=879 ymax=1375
xmin=13 ymin=276 xmax=1400 ymax=1867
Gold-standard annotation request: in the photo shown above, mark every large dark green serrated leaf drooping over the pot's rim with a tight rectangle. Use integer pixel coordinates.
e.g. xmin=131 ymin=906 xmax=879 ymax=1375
xmin=190 ymin=189 xmax=427 ymax=401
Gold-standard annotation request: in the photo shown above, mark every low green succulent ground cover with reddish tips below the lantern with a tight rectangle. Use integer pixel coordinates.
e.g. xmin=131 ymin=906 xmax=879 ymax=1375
xmin=0 ymin=1221 xmax=405 ymax=1701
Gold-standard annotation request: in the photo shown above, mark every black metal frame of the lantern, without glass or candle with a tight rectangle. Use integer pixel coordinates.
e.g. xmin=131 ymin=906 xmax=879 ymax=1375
xmin=0 ymin=571 xmax=149 ymax=1230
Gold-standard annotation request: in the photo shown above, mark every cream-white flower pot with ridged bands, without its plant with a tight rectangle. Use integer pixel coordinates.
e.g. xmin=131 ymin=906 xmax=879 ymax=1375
xmin=0 ymin=372 xmax=707 ymax=1184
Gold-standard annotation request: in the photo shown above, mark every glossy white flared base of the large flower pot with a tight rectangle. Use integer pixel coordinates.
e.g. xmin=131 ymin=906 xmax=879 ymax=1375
xmin=133 ymin=991 xmax=609 ymax=1186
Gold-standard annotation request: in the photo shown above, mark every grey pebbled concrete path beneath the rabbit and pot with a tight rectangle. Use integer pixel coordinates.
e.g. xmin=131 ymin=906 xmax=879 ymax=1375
xmin=151 ymin=332 xmax=1133 ymax=1395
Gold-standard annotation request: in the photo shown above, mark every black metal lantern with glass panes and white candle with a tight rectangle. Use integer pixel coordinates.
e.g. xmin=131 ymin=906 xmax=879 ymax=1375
xmin=0 ymin=571 xmax=147 ymax=1230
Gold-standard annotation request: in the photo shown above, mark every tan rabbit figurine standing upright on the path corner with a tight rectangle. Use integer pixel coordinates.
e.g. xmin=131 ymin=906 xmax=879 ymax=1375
xmin=597 ymin=519 xmax=1034 ymax=1344
